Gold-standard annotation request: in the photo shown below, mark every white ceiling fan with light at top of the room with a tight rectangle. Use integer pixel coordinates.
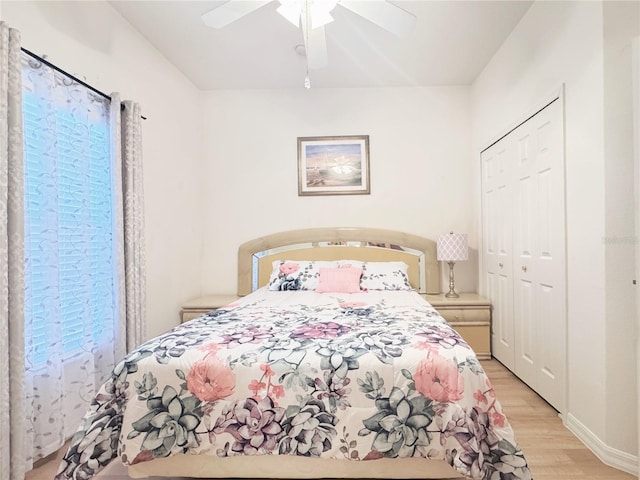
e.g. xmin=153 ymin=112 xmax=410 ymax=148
xmin=202 ymin=0 xmax=416 ymax=69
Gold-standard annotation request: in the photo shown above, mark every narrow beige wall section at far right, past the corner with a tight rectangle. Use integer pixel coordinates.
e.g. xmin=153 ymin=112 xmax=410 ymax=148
xmin=603 ymin=1 xmax=640 ymax=453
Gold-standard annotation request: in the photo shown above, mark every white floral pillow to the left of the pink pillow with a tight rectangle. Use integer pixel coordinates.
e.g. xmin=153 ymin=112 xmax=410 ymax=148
xmin=267 ymin=260 xmax=338 ymax=291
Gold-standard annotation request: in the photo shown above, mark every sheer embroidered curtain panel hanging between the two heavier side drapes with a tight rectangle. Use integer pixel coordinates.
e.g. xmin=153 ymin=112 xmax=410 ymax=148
xmin=22 ymin=49 xmax=124 ymax=460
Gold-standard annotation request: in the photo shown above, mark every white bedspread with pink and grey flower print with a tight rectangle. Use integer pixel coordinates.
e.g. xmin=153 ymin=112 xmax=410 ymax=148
xmin=56 ymin=289 xmax=531 ymax=480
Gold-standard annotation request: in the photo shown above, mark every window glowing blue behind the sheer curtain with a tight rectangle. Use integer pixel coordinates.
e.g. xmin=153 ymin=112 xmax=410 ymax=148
xmin=23 ymin=54 xmax=117 ymax=368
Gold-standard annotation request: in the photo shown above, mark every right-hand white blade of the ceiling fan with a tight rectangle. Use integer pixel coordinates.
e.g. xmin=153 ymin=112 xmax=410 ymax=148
xmin=338 ymin=0 xmax=416 ymax=37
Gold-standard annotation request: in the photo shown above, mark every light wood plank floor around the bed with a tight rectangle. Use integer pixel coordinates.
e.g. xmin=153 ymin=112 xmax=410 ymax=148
xmin=25 ymin=360 xmax=636 ymax=480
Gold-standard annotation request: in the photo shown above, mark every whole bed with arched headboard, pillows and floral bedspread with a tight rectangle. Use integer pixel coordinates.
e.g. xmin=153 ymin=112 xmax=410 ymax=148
xmin=56 ymin=228 xmax=531 ymax=480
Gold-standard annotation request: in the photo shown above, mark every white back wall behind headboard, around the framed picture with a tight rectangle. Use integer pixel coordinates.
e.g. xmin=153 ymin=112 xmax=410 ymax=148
xmin=203 ymin=87 xmax=477 ymax=293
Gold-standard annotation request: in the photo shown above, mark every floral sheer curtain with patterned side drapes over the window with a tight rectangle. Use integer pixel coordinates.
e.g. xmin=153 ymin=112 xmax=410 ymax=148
xmin=0 ymin=20 xmax=146 ymax=474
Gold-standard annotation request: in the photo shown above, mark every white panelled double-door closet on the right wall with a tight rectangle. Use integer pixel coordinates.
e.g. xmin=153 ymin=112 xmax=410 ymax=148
xmin=481 ymin=98 xmax=567 ymax=412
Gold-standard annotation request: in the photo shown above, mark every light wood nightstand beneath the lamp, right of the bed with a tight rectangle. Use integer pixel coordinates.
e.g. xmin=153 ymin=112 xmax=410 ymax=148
xmin=422 ymin=293 xmax=491 ymax=360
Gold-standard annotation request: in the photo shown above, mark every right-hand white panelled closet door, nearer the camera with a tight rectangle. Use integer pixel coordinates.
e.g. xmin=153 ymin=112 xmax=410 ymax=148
xmin=513 ymin=98 xmax=566 ymax=410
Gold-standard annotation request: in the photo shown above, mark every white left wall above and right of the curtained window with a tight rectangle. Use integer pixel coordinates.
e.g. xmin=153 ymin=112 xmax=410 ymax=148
xmin=2 ymin=1 xmax=203 ymax=337
